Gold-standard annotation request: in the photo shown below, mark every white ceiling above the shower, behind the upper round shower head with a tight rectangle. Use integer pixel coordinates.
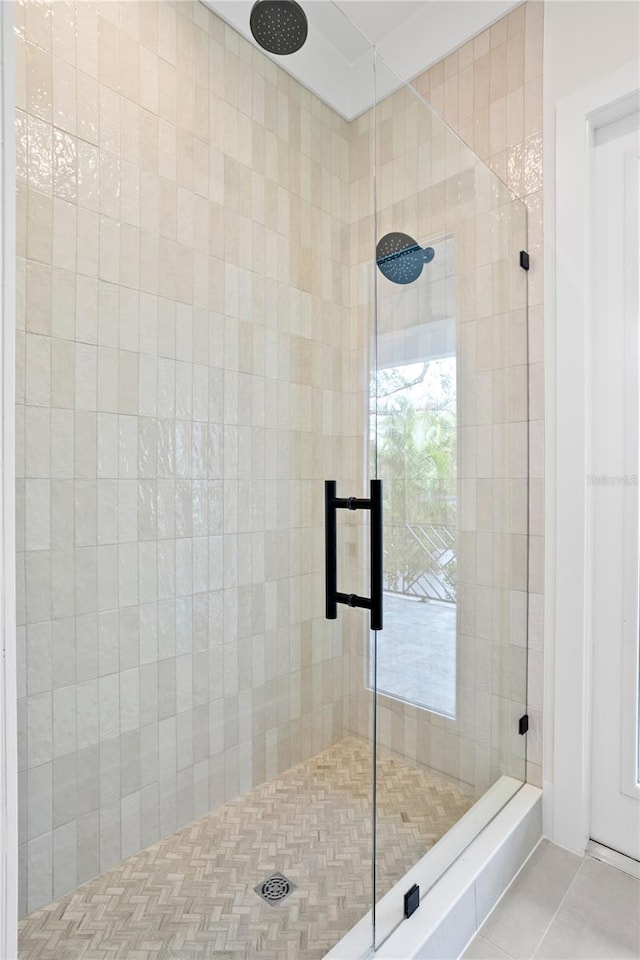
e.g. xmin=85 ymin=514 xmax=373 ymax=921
xmin=203 ymin=0 xmax=520 ymax=120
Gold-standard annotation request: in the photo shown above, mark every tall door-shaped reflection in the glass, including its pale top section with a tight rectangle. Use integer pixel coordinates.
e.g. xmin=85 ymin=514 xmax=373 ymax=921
xmin=368 ymin=232 xmax=458 ymax=717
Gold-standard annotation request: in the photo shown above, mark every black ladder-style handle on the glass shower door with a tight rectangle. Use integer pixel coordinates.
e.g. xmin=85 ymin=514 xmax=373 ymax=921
xmin=324 ymin=480 xmax=383 ymax=630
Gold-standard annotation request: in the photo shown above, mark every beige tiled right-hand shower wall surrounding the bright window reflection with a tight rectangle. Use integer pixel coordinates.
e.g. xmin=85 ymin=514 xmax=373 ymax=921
xmin=345 ymin=2 xmax=543 ymax=792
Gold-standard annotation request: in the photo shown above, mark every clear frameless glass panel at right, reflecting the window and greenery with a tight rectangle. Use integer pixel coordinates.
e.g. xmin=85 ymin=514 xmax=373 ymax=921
xmin=368 ymin=50 xmax=528 ymax=944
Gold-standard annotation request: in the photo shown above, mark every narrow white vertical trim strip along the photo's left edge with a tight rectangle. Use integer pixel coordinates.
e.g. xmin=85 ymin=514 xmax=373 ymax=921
xmin=0 ymin=3 xmax=18 ymax=960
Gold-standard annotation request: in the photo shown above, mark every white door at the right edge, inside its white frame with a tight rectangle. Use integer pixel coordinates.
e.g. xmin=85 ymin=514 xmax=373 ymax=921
xmin=587 ymin=114 xmax=640 ymax=860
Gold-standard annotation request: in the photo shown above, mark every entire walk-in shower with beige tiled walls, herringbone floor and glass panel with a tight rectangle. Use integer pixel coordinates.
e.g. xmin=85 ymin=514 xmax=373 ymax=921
xmin=15 ymin=0 xmax=528 ymax=960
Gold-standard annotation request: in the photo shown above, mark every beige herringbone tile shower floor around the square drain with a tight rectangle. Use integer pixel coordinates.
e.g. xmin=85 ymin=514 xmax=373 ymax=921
xmin=19 ymin=737 xmax=473 ymax=960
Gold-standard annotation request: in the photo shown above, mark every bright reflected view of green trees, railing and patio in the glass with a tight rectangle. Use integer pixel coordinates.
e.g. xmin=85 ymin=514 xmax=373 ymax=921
xmin=369 ymin=350 xmax=457 ymax=717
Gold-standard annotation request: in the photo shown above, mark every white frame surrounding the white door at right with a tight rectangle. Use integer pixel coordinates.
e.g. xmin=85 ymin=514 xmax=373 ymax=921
xmin=544 ymin=62 xmax=640 ymax=854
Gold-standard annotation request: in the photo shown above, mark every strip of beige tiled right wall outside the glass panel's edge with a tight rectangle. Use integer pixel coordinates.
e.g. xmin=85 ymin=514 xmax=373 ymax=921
xmin=414 ymin=0 xmax=544 ymax=786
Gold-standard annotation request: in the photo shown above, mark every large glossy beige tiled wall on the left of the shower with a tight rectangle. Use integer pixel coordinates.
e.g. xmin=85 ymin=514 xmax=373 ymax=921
xmin=16 ymin=0 xmax=359 ymax=915
